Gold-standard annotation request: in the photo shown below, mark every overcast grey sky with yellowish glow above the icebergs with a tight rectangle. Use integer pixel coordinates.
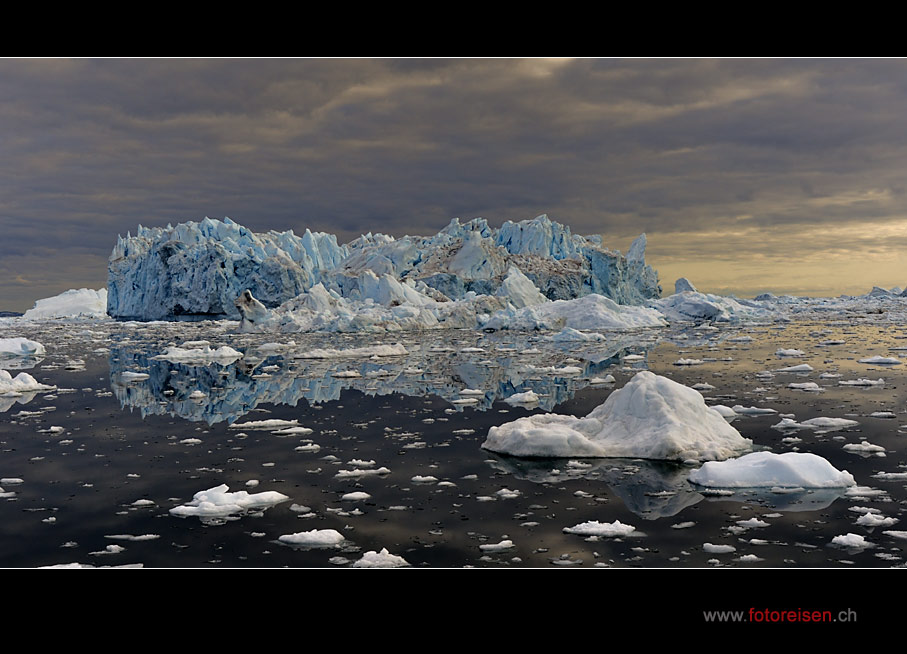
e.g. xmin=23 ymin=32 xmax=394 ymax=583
xmin=0 ymin=59 xmax=907 ymax=311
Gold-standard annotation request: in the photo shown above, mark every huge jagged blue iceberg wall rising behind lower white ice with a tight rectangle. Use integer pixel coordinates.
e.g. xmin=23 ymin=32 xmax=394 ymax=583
xmin=107 ymin=215 xmax=661 ymax=320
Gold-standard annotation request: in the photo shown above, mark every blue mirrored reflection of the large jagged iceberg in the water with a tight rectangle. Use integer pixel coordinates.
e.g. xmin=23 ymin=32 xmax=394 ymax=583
xmin=109 ymin=335 xmax=657 ymax=424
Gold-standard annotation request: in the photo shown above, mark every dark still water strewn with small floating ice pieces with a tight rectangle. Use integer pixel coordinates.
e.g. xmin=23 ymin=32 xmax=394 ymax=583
xmin=0 ymin=319 xmax=907 ymax=568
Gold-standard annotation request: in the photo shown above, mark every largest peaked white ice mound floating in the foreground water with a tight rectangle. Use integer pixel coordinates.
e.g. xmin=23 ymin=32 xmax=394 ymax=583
xmin=482 ymin=370 xmax=753 ymax=461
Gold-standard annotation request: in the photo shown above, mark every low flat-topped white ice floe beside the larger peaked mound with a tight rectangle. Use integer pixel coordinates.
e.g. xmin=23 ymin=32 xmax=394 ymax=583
xmin=690 ymin=452 xmax=856 ymax=488
